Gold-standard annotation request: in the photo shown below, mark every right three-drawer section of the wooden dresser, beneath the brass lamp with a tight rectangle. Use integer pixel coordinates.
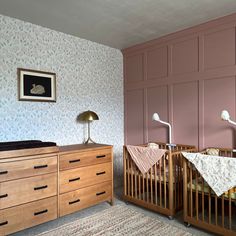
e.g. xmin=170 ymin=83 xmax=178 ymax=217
xmin=59 ymin=144 xmax=113 ymax=216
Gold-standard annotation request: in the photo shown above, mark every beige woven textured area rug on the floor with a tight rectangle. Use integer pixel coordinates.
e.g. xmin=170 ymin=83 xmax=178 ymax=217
xmin=39 ymin=205 xmax=192 ymax=236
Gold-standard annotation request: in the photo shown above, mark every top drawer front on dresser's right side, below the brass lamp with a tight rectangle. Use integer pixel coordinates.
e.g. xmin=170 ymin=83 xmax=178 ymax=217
xmin=59 ymin=148 xmax=111 ymax=170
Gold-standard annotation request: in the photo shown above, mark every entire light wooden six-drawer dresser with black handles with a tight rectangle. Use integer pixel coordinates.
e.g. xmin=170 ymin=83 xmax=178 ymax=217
xmin=0 ymin=144 xmax=113 ymax=235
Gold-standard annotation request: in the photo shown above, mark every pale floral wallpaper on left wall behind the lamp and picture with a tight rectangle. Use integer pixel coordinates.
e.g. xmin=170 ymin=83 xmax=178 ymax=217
xmin=0 ymin=15 xmax=124 ymax=184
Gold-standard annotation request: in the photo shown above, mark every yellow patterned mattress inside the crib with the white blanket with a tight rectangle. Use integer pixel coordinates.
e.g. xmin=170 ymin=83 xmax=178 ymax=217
xmin=187 ymin=179 xmax=236 ymax=200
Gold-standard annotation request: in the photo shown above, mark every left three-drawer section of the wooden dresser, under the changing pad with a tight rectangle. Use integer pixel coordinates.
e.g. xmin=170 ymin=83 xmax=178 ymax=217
xmin=0 ymin=146 xmax=58 ymax=235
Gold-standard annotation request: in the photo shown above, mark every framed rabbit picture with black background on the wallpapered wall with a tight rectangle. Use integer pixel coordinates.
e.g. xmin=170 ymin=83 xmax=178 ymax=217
xmin=17 ymin=68 xmax=56 ymax=102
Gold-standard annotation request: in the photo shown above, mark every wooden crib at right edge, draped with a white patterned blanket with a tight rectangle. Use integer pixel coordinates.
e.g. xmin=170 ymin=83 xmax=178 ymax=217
xmin=183 ymin=148 xmax=236 ymax=236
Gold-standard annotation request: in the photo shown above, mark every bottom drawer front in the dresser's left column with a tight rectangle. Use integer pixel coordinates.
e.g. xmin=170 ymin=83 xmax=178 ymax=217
xmin=0 ymin=197 xmax=57 ymax=235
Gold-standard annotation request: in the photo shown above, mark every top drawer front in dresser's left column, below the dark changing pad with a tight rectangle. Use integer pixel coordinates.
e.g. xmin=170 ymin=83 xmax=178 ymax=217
xmin=0 ymin=156 xmax=57 ymax=182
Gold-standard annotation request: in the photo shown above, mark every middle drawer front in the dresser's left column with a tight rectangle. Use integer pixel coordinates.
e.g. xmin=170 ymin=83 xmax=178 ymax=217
xmin=0 ymin=173 xmax=57 ymax=209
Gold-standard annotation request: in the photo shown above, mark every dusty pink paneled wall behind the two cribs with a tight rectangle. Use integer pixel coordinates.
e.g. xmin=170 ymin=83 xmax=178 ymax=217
xmin=123 ymin=14 xmax=236 ymax=148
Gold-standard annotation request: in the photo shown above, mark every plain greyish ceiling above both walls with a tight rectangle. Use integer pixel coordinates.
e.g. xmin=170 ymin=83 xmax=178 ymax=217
xmin=0 ymin=0 xmax=236 ymax=49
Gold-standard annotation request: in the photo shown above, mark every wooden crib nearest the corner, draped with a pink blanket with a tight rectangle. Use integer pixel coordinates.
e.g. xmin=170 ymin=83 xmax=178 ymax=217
xmin=123 ymin=143 xmax=196 ymax=218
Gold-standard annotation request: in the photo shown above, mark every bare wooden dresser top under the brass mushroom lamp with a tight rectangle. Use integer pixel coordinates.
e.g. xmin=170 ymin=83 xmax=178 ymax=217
xmin=59 ymin=143 xmax=112 ymax=153
